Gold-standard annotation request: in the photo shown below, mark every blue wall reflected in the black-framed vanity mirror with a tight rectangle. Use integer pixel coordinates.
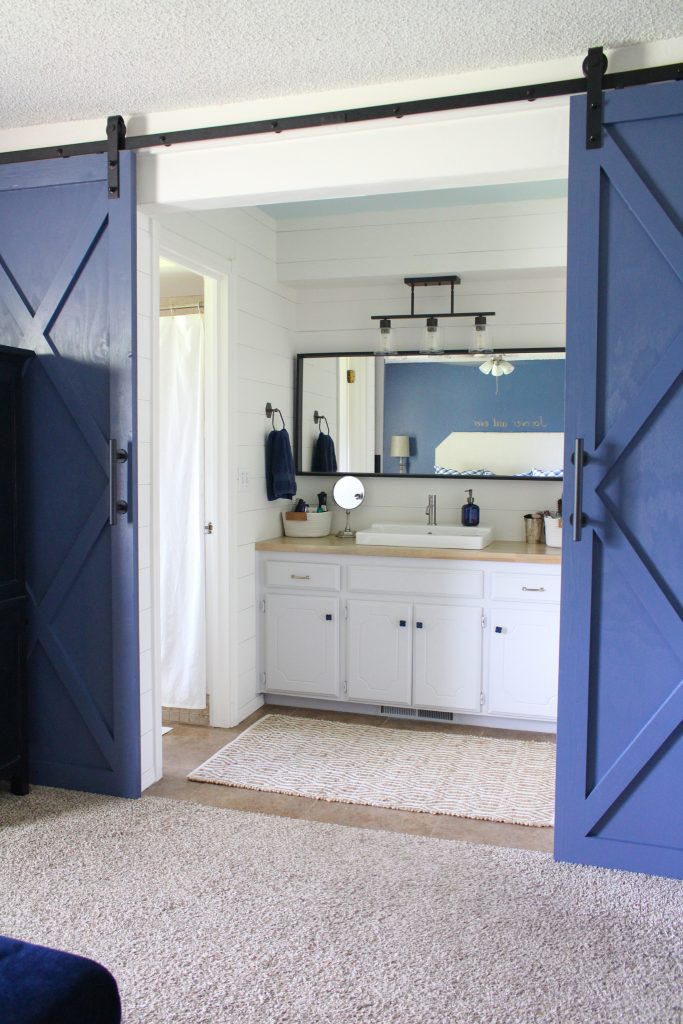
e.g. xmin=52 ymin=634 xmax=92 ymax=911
xmin=382 ymin=356 xmax=564 ymax=474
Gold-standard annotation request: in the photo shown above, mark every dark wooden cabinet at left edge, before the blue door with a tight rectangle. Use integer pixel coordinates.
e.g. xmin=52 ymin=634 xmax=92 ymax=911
xmin=0 ymin=345 xmax=32 ymax=795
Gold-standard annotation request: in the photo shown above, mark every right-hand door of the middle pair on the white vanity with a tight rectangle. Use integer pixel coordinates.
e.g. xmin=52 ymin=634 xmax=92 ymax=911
xmin=413 ymin=604 xmax=482 ymax=712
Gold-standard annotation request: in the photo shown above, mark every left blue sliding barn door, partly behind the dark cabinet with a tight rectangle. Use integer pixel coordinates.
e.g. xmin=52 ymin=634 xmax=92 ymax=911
xmin=0 ymin=154 xmax=140 ymax=797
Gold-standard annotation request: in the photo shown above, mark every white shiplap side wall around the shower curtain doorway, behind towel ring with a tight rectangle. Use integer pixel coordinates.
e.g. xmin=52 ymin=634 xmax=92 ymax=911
xmin=137 ymin=203 xmax=294 ymax=786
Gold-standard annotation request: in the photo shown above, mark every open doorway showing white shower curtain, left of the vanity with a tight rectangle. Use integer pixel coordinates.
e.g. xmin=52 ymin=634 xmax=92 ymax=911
xmin=155 ymin=256 xmax=218 ymax=731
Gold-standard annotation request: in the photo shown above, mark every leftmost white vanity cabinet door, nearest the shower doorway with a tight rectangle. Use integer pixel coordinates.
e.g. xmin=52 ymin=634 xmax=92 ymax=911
xmin=265 ymin=594 xmax=339 ymax=696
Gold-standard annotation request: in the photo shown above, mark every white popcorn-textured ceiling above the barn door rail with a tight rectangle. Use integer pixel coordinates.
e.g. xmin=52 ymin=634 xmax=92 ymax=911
xmin=0 ymin=0 xmax=683 ymax=127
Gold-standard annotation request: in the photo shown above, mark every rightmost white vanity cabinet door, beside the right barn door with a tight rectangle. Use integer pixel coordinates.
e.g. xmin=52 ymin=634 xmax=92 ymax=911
xmin=487 ymin=608 xmax=560 ymax=719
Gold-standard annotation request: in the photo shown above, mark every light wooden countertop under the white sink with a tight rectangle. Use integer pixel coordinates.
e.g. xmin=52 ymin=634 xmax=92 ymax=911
xmin=256 ymin=535 xmax=561 ymax=565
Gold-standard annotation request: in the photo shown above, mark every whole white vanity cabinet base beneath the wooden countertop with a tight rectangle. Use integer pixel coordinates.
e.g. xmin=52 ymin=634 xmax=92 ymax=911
xmin=260 ymin=548 xmax=560 ymax=729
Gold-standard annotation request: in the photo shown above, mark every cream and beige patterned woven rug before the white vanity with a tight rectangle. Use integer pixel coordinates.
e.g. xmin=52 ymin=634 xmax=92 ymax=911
xmin=187 ymin=715 xmax=555 ymax=825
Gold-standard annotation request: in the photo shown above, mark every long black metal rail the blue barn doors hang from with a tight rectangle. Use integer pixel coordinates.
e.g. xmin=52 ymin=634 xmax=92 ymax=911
xmin=0 ymin=56 xmax=683 ymax=165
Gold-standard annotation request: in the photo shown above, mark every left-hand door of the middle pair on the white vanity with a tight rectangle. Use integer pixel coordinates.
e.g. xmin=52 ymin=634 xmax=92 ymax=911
xmin=347 ymin=601 xmax=412 ymax=705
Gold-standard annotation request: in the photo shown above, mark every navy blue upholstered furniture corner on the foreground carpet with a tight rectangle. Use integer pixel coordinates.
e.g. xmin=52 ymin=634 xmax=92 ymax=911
xmin=0 ymin=936 xmax=121 ymax=1024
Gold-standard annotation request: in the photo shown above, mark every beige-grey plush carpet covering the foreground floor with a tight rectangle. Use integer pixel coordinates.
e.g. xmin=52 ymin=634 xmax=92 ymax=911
xmin=0 ymin=790 xmax=683 ymax=1024
